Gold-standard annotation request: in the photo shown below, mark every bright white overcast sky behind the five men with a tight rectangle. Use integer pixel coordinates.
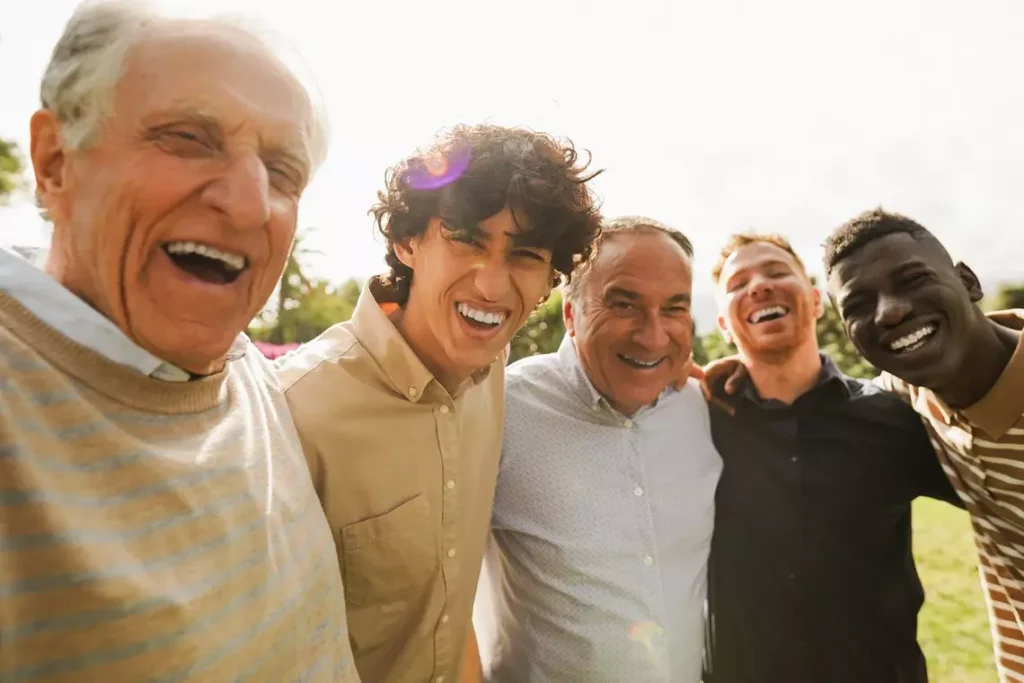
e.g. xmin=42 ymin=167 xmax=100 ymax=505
xmin=0 ymin=0 xmax=1024 ymax=328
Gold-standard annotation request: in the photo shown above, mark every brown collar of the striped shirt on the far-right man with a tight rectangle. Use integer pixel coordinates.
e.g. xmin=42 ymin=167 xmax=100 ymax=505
xmin=958 ymin=308 xmax=1024 ymax=438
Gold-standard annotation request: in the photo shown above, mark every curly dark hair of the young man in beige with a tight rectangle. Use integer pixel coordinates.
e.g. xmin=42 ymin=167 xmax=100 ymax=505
xmin=370 ymin=125 xmax=601 ymax=305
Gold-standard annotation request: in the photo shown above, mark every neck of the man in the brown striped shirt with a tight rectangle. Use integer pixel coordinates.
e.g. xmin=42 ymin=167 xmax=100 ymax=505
xmin=934 ymin=313 xmax=1020 ymax=409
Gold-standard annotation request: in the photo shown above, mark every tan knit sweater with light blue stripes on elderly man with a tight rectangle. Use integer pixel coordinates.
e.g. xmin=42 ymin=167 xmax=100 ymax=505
xmin=0 ymin=292 xmax=358 ymax=683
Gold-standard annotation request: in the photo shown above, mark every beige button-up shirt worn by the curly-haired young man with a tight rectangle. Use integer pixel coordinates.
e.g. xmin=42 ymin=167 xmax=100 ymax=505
xmin=280 ymin=281 xmax=505 ymax=683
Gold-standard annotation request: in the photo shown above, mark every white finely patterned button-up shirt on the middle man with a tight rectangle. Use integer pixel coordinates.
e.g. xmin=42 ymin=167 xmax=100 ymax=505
xmin=475 ymin=337 xmax=722 ymax=683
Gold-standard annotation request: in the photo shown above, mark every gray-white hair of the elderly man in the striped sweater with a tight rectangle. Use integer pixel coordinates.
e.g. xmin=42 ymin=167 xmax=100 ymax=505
xmin=40 ymin=0 xmax=329 ymax=162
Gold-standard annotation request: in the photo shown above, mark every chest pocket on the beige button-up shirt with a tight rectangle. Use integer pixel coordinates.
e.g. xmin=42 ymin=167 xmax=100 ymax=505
xmin=341 ymin=494 xmax=439 ymax=607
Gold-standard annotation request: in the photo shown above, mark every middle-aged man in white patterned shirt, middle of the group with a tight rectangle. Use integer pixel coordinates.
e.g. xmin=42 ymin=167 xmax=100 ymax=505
xmin=476 ymin=217 xmax=722 ymax=683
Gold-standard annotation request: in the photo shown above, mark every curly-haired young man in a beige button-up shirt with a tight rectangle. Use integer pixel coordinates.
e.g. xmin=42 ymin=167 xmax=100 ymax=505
xmin=282 ymin=125 xmax=601 ymax=683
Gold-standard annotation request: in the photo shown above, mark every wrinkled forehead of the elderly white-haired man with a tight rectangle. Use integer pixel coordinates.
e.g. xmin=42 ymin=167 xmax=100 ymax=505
xmin=115 ymin=19 xmax=313 ymax=158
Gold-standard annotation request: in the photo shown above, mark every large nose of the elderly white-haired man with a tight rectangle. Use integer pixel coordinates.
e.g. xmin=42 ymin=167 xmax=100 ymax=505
xmin=205 ymin=154 xmax=270 ymax=229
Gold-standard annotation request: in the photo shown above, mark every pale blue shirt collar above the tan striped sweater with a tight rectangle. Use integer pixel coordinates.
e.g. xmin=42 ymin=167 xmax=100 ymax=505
xmin=0 ymin=247 xmax=241 ymax=382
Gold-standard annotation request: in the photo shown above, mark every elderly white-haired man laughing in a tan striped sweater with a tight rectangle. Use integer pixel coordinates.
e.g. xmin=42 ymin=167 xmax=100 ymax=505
xmin=0 ymin=2 xmax=358 ymax=683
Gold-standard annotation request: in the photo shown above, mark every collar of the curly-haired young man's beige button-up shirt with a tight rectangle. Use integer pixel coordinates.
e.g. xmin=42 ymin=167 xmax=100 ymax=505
xmin=352 ymin=276 xmax=490 ymax=402
